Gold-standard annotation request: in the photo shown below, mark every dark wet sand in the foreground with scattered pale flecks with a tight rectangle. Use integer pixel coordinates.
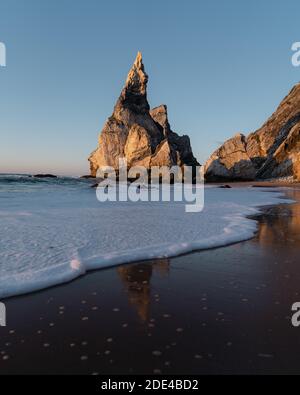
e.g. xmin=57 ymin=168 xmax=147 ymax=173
xmin=0 ymin=188 xmax=300 ymax=374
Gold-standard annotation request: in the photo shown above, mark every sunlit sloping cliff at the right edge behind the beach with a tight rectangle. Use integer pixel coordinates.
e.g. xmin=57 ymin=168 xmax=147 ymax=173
xmin=204 ymin=84 xmax=300 ymax=181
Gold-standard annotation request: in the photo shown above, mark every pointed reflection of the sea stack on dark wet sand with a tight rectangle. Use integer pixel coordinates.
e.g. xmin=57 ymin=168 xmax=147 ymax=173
xmin=117 ymin=259 xmax=170 ymax=322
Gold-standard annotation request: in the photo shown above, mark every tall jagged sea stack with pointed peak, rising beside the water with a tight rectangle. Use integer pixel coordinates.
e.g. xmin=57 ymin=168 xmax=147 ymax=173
xmin=89 ymin=52 xmax=198 ymax=176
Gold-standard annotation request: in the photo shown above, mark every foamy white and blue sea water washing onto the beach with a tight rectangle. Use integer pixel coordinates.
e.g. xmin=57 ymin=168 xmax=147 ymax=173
xmin=0 ymin=175 xmax=289 ymax=298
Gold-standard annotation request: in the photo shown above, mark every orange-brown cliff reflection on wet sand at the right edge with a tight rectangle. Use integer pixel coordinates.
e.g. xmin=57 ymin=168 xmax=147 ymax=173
xmin=257 ymin=190 xmax=300 ymax=247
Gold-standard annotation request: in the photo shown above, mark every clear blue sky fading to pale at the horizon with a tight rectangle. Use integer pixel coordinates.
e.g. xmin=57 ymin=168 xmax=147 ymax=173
xmin=0 ymin=0 xmax=300 ymax=175
